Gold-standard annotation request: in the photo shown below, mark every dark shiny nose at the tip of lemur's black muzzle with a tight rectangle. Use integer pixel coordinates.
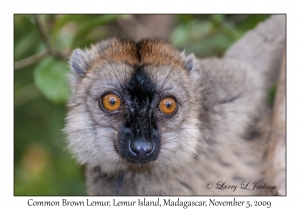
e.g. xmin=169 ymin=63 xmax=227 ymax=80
xmin=129 ymin=141 xmax=154 ymax=161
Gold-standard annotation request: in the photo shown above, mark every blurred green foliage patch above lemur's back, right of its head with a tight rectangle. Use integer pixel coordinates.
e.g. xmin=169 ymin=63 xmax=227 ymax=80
xmin=171 ymin=15 xmax=269 ymax=57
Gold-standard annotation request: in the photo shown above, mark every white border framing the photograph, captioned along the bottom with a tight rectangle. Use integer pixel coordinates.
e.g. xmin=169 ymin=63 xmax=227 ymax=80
xmin=0 ymin=0 xmax=300 ymax=209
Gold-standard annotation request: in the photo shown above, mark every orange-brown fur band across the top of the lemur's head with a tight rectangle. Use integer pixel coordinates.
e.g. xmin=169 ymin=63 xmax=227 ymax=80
xmin=92 ymin=38 xmax=184 ymax=69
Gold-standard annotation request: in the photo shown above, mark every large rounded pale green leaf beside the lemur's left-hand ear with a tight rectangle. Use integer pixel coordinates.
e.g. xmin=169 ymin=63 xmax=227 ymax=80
xmin=34 ymin=57 xmax=69 ymax=104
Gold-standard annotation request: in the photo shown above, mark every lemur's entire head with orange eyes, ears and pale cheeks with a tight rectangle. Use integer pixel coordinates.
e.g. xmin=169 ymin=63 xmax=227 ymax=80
xmin=65 ymin=38 xmax=201 ymax=173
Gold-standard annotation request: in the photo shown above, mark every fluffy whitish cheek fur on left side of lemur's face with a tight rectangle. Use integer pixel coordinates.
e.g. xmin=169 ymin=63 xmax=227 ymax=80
xmin=64 ymin=104 xmax=122 ymax=173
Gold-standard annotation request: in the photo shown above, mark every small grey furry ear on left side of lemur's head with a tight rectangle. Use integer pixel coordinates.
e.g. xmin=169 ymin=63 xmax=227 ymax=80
xmin=70 ymin=49 xmax=89 ymax=77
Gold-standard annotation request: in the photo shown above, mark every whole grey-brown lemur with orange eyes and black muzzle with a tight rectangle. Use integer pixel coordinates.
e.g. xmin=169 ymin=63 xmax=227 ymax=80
xmin=64 ymin=15 xmax=285 ymax=195
